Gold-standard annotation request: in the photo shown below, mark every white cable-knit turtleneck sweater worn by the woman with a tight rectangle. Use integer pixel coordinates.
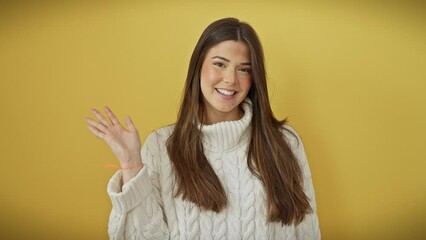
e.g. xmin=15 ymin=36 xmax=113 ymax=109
xmin=107 ymin=99 xmax=321 ymax=240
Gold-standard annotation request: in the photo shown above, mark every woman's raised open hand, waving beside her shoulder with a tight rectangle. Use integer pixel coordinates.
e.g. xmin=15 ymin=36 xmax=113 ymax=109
xmin=85 ymin=107 xmax=141 ymax=168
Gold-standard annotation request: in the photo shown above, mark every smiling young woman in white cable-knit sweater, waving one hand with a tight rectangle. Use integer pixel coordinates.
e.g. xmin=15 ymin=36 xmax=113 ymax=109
xmin=86 ymin=18 xmax=320 ymax=240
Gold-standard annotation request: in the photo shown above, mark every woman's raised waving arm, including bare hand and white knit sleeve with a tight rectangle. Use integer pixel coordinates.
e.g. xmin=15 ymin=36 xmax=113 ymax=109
xmin=86 ymin=108 xmax=169 ymax=240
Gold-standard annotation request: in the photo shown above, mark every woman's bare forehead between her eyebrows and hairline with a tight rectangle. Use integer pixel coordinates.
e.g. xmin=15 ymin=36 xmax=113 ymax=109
xmin=207 ymin=40 xmax=250 ymax=61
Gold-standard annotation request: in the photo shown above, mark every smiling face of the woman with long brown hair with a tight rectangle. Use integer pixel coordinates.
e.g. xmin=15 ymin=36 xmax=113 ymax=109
xmin=200 ymin=40 xmax=252 ymax=124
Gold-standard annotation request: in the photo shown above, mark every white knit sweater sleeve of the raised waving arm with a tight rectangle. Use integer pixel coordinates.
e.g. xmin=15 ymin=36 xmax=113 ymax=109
xmin=107 ymin=132 xmax=169 ymax=240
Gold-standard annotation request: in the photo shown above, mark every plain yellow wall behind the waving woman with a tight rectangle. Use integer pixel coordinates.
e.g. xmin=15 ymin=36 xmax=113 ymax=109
xmin=0 ymin=0 xmax=426 ymax=240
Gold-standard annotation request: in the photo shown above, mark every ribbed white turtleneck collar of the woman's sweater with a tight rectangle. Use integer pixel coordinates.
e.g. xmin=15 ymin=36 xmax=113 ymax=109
xmin=198 ymin=98 xmax=253 ymax=151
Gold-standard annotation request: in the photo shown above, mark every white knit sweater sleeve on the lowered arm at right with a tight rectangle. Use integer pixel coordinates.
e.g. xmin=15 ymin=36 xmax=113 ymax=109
xmin=286 ymin=125 xmax=321 ymax=240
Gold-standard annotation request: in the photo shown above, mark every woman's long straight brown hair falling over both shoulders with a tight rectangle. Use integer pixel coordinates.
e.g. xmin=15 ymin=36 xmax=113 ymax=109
xmin=167 ymin=18 xmax=312 ymax=225
